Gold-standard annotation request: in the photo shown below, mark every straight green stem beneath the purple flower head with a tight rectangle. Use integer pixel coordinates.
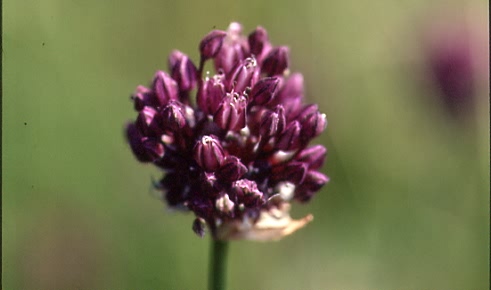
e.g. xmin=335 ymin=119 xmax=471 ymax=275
xmin=208 ymin=240 xmax=228 ymax=290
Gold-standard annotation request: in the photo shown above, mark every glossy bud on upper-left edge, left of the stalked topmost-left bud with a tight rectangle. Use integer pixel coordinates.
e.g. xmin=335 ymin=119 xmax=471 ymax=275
xmin=169 ymin=50 xmax=197 ymax=92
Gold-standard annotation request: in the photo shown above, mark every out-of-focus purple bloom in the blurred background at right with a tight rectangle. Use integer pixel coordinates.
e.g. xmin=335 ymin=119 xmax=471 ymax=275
xmin=421 ymin=15 xmax=489 ymax=120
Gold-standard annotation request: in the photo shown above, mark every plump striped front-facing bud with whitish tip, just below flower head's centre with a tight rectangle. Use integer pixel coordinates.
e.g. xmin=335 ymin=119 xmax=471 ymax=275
xmin=194 ymin=135 xmax=225 ymax=172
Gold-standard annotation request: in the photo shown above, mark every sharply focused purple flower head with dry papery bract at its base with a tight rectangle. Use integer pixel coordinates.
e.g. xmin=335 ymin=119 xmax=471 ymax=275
xmin=126 ymin=23 xmax=328 ymax=239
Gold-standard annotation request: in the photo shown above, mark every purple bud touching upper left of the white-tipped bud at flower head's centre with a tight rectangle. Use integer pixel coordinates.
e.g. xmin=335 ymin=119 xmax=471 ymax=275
xmin=196 ymin=75 xmax=225 ymax=115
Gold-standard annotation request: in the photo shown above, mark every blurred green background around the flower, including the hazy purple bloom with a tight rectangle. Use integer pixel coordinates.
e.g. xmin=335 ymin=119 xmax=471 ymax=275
xmin=2 ymin=0 xmax=490 ymax=290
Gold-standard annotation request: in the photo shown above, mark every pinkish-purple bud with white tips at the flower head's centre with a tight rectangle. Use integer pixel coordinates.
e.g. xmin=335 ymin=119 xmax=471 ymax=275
xmin=213 ymin=94 xmax=247 ymax=131
